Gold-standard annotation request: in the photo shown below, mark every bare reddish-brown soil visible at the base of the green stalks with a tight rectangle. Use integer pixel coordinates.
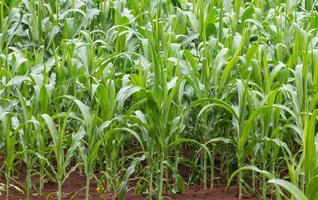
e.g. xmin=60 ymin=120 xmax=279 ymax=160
xmin=0 ymin=173 xmax=254 ymax=200
